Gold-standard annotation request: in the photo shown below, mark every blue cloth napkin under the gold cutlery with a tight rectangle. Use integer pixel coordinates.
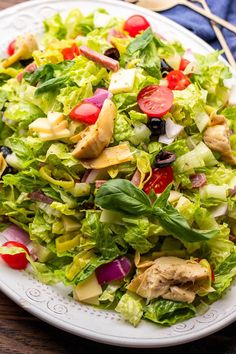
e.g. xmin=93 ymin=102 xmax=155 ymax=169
xmin=157 ymin=0 xmax=236 ymax=59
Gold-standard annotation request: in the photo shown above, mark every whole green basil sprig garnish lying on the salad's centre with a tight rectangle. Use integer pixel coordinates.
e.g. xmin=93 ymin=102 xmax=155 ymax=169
xmin=95 ymin=179 xmax=218 ymax=242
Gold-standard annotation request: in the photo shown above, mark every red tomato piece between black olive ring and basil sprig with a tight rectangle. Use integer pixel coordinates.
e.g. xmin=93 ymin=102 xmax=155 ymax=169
xmin=143 ymin=166 xmax=174 ymax=194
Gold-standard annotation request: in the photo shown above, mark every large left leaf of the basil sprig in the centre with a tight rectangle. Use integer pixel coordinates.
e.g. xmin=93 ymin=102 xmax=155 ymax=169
xmin=95 ymin=179 xmax=151 ymax=215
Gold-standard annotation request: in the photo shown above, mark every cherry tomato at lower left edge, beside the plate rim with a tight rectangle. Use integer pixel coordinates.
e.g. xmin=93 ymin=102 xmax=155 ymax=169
xmin=1 ymin=241 xmax=30 ymax=270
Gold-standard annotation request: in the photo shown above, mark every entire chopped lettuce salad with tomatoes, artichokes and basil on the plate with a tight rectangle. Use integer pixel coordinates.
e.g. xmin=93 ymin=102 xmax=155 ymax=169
xmin=0 ymin=9 xmax=236 ymax=326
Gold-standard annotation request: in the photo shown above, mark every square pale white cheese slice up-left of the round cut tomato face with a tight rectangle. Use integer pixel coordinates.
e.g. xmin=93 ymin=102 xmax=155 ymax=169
xmin=108 ymin=69 xmax=136 ymax=94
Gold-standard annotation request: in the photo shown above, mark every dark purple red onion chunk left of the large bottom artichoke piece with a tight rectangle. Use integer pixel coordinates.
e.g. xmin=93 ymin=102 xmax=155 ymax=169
xmin=96 ymin=257 xmax=132 ymax=284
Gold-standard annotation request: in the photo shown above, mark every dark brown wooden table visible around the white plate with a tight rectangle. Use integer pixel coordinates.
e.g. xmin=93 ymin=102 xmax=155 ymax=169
xmin=0 ymin=0 xmax=236 ymax=354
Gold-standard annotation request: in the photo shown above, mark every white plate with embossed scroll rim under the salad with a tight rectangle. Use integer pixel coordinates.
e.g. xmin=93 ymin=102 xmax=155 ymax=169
xmin=0 ymin=0 xmax=236 ymax=347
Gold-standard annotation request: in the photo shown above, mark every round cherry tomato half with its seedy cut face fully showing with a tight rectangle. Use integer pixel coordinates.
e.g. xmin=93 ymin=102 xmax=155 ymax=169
xmin=137 ymin=85 xmax=174 ymax=117
